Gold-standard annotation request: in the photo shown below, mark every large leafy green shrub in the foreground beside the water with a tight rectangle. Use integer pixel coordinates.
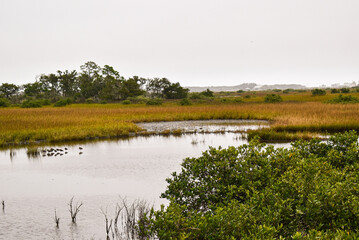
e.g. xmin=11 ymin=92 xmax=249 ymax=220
xmin=145 ymin=131 xmax=359 ymax=239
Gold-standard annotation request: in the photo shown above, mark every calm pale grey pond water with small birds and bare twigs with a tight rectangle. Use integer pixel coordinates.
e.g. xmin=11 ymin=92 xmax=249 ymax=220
xmin=0 ymin=120 xmax=287 ymax=239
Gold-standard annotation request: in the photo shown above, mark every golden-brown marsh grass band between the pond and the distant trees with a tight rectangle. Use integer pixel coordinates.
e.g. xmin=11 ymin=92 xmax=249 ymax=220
xmin=0 ymin=102 xmax=359 ymax=146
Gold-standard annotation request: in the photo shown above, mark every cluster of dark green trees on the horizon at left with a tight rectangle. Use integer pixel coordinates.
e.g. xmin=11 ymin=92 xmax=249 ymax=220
xmin=0 ymin=61 xmax=189 ymax=103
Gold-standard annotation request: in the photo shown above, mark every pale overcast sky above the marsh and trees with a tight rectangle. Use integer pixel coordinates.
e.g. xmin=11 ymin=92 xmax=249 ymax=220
xmin=0 ymin=0 xmax=359 ymax=86
